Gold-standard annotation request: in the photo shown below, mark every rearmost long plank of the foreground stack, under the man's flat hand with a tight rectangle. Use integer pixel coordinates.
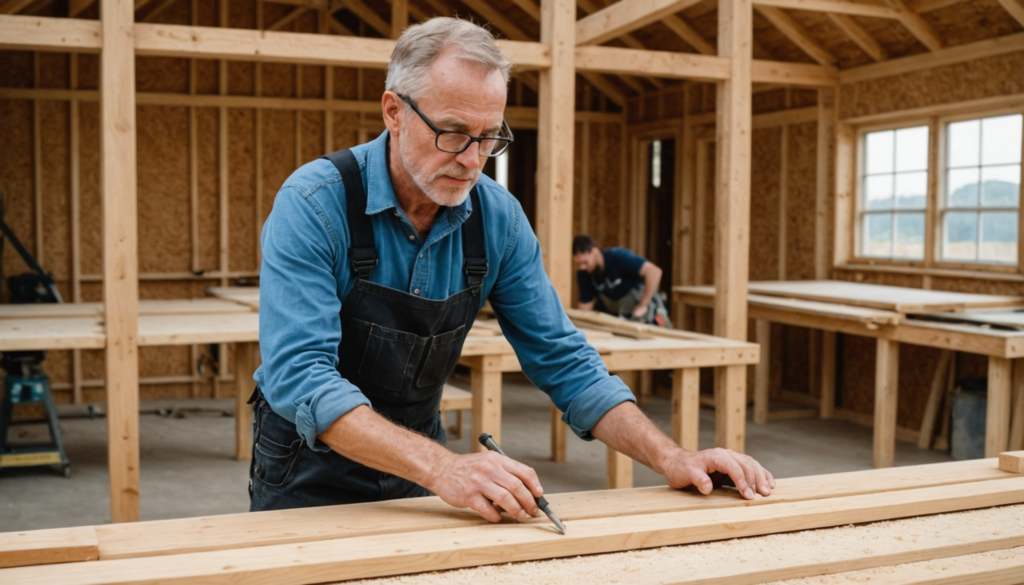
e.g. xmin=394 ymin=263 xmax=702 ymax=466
xmin=88 ymin=459 xmax=1013 ymax=560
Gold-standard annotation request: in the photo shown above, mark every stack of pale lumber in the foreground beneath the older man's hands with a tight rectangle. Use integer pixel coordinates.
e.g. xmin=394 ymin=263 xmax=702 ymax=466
xmin=0 ymin=453 xmax=1024 ymax=584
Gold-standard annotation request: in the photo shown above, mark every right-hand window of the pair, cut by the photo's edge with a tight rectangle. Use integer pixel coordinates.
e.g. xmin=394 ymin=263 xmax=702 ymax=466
xmin=940 ymin=114 xmax=1022 ymax=264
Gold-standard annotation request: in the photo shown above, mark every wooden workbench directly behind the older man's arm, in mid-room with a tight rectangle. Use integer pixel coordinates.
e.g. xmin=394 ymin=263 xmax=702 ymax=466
xmin=459 ymin=311 xmax=761 ymax=489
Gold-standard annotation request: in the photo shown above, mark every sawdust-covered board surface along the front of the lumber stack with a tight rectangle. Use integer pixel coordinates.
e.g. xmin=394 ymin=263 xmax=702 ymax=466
xmin=349 ymin=505 xmax=1024 ymax=585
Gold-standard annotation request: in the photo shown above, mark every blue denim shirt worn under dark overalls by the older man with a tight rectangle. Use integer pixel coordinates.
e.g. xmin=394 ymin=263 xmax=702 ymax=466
xmin=254 ymin=131 xmax=634 ymax=451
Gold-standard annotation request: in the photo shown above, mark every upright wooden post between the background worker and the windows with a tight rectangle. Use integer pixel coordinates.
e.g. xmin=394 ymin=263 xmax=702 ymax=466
xmin=715 ymin=0 xmax=754 ymax=453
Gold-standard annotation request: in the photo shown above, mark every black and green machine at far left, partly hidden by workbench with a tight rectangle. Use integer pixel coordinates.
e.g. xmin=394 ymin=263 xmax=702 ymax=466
xmin=0 ymin=200 xmax=71 ymax=477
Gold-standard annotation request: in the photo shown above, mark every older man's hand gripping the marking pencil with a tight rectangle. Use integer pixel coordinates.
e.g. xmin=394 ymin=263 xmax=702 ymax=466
xmin=425 ymin=452 xmax=544 ymax=523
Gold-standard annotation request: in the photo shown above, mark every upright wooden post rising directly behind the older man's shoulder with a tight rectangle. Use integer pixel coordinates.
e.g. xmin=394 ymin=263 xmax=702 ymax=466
xmin=537 ymin=0 xmax=577 ymax=306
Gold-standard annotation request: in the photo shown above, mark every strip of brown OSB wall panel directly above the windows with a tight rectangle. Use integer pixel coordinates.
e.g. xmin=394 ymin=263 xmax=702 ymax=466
xmin=840 ymin=52 xmax=1024 ymax=119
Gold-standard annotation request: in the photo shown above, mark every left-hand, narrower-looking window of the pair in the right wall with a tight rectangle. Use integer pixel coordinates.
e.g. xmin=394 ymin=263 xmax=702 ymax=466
xmin=860 ymin=126 xmax=928 ymax=260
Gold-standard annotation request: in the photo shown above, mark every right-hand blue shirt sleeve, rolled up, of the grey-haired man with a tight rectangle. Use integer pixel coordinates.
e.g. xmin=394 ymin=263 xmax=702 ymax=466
xmin=489 ymin=207 xmax=635 ymax=441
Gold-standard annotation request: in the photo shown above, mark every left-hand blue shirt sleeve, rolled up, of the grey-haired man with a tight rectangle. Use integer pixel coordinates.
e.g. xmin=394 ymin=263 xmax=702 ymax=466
xmin=258 ymin=186 xmax=370 ymax=451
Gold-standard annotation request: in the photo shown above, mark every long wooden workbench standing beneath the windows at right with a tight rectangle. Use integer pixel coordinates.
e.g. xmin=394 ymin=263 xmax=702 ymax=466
xmin=673 ymin=281 xmax=1024 ymax=467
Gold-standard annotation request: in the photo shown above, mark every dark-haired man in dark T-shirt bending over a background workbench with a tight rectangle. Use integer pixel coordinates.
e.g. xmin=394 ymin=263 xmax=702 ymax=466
xmin=572 ymin=234 xmax=672 ymax=327
